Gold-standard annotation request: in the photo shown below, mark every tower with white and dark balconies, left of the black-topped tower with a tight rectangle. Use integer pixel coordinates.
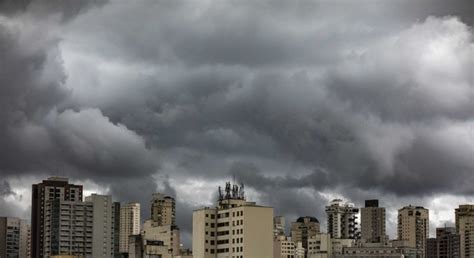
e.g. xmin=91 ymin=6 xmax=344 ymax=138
xmin=326 ymin=199 xmax=359 ymax=239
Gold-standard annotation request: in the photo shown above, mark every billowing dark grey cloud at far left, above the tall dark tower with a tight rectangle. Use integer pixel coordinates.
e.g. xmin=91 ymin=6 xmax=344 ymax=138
xmin=0 ymin=1 xmax=158 ymax=217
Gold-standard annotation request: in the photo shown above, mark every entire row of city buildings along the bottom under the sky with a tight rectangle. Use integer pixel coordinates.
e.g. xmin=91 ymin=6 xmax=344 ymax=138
xmin=0 ymin=177 xmax=474 ymax=258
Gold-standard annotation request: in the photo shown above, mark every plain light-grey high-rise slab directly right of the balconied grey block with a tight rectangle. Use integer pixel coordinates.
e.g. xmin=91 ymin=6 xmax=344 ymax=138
xmin=85 ymin=194 xmax=114 ymax=258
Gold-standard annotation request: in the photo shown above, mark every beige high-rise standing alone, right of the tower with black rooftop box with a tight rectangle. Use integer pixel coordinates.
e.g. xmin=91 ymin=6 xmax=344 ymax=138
xmin=397 ymin=205 xmax=430 ymax=258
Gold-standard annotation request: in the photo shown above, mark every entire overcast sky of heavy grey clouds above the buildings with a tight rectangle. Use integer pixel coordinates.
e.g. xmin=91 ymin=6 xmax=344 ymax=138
xmin=0 ymin=0 xmax=474 ymax=247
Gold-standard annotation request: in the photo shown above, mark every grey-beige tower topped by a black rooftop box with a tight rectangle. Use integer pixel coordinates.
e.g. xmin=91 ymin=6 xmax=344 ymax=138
xmin=360 ymin=200 xmax=388 ymax=243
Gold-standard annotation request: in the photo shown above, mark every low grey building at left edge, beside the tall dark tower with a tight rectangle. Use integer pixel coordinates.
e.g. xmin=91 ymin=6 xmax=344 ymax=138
xmin=0 ymin=217 xmax=30 ymax=258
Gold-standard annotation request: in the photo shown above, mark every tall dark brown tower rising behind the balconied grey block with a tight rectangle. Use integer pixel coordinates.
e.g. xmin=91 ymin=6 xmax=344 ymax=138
xmin=31 ymin=177 xmax=82 ymax=258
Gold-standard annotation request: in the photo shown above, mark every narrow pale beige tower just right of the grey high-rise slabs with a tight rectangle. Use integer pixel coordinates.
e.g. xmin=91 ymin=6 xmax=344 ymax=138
xmin=119 ymin=202 xmax=140 ymax=253
